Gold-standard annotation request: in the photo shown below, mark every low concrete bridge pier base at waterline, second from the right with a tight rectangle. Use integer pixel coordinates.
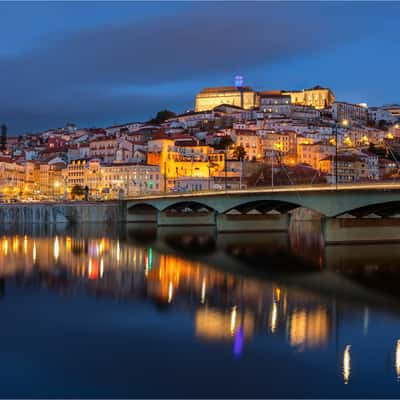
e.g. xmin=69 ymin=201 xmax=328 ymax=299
xmin=216 ymin=214 xmax=290 ymax=232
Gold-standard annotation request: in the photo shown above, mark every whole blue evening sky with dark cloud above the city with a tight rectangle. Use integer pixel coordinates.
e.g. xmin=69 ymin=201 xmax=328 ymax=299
xmin=0 ymin=1 xmax=400 ymax=134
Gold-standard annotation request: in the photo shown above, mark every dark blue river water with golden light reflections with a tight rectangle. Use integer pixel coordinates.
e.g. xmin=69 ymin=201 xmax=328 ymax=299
xmin=0 ymin=222 xmax=400 ymax=398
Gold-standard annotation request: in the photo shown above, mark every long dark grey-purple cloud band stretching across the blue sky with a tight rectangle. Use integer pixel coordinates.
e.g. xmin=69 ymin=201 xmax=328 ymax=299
xmin=0 ymin=3 xmax=395 ymax=131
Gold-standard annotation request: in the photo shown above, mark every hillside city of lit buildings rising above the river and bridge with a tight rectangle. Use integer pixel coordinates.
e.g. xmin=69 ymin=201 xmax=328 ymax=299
xmin=0 ymin=80 xmax=400 ymax=201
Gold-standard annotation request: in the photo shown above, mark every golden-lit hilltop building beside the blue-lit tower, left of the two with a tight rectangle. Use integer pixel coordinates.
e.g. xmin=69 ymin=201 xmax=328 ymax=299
xmin=196 ymin=86 xmax=259 ymax=112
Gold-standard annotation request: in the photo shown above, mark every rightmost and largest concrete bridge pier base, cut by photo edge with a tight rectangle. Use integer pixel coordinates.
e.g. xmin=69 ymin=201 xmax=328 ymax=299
xmin=322 ymin=218 xmax=400 ymax=244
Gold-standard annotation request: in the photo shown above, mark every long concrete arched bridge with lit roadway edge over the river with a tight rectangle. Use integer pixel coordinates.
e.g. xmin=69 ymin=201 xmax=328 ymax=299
xmin=126 ymin=182 xmax=400 ymax=243
